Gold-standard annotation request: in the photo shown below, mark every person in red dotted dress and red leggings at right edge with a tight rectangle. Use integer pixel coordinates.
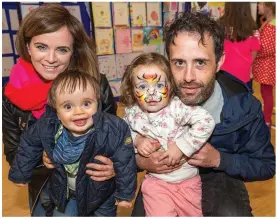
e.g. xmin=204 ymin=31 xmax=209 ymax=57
xmin=253 ymin=2 xmax=276 ymax=128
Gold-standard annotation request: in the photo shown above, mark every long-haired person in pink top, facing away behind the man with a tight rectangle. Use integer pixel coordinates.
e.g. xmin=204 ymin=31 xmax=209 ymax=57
xmin=219 ymin=2 xmax=260 ymax=89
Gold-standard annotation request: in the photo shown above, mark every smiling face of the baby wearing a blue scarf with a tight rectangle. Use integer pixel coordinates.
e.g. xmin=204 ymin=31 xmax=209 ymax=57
xmin=56 ymin=84 xmax=98 ymax=136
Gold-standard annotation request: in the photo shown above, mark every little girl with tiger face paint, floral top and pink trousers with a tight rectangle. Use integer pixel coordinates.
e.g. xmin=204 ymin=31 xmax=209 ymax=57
xmin=121 ymin=53 xmax=215 ymax=216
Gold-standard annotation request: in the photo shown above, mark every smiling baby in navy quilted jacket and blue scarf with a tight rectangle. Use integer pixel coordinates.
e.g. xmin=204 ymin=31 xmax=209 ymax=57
xmin=9 ymin=70 xmax=137 ymax=216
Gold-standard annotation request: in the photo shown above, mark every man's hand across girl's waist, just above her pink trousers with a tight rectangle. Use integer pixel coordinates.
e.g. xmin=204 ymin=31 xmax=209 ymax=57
xmin=136 ymin=151 xmax=186 ymax=173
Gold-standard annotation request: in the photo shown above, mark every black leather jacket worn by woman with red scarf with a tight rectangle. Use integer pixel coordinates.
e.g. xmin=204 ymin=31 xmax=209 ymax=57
xmin=2 ymin=74 xmax=117 ymax=212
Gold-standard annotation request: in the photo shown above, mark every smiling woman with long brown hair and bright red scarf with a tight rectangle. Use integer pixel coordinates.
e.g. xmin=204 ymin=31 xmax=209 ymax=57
xmin=2 ymin=4 xmax=116 ymax=216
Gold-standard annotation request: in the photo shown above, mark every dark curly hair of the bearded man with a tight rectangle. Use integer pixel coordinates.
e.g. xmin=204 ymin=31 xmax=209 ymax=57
xmin=164 ymin=12 xmax=224 ymax=62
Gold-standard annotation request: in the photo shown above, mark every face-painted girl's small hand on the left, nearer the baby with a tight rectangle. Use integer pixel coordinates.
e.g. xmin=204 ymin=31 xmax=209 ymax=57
xmin=135 ymin=135 xmax=161 ymax=157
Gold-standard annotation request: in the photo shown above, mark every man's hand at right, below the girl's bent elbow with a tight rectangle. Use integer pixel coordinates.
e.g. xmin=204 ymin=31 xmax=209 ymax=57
xmin=188 ymin=143 xmax=220 ymax=168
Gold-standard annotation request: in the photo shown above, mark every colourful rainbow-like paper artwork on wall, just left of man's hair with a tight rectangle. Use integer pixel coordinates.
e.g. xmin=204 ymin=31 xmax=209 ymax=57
xmin=143 ymin=27 xmax=163 ymax=45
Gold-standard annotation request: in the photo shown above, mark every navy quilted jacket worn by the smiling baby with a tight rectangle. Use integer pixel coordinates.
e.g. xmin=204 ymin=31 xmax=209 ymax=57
xmin=9 ymin=107 xmax=137 ymax=216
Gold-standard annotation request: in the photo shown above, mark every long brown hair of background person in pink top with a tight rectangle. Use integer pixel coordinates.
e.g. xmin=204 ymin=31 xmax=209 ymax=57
xmin=219 ymin=2 xmax=257 ymax=42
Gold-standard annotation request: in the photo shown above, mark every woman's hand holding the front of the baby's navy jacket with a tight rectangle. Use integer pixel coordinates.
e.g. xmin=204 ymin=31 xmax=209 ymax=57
xmin=86 ymin=155 xmax=115 ymax=181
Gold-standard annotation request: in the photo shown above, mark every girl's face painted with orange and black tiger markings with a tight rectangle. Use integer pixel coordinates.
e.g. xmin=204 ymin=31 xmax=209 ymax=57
xmin=133 ymin=65 xmax=169 ymax=113
